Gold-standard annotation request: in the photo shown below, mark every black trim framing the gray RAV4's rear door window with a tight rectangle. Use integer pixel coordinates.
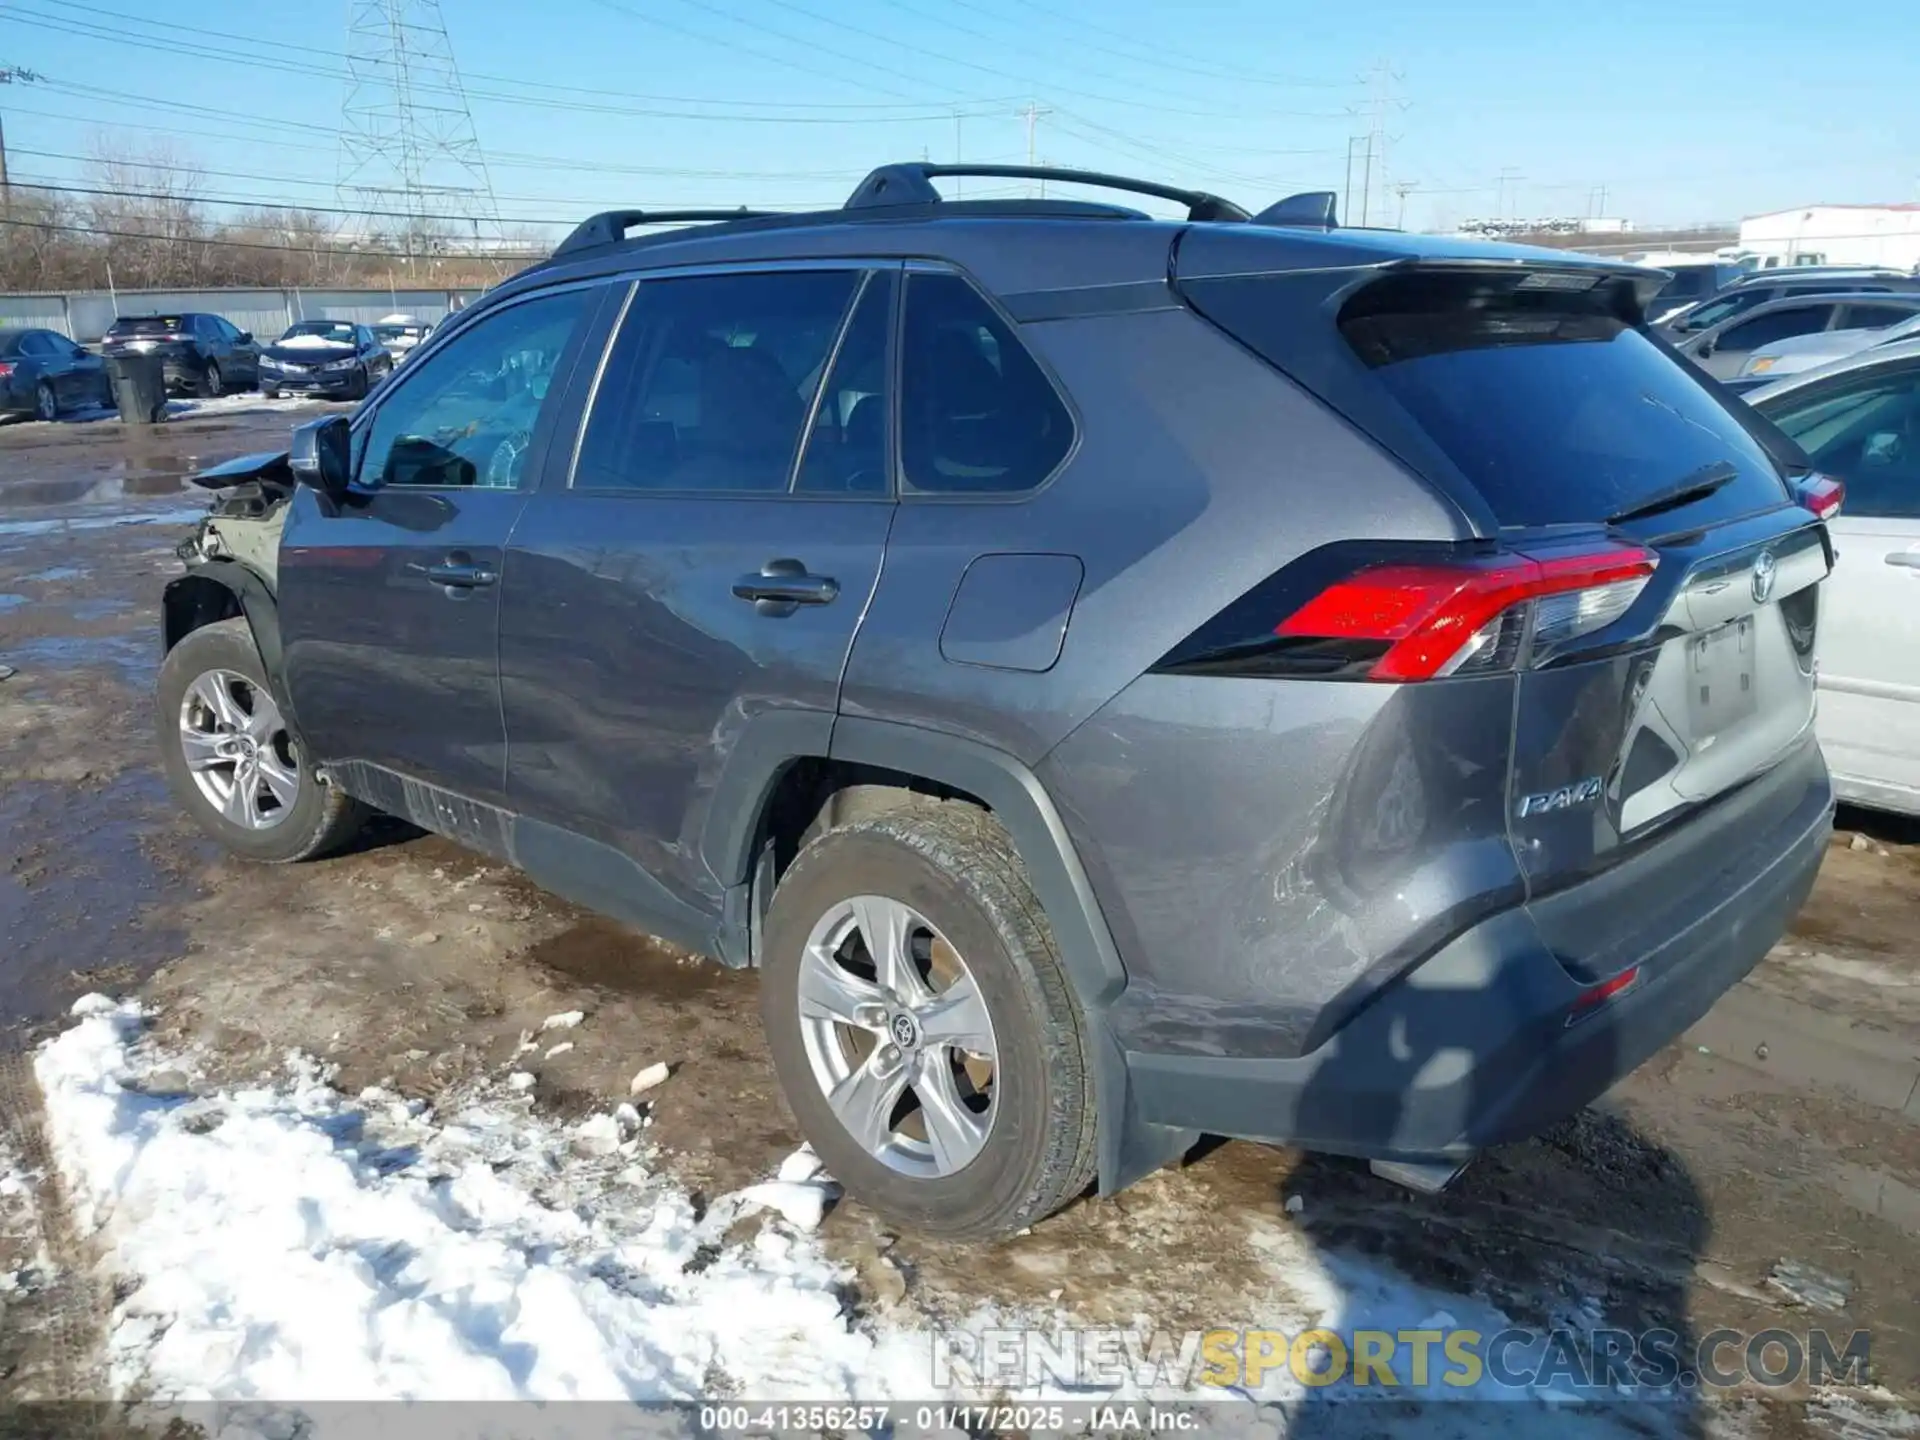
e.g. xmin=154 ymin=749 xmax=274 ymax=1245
xmin=559 ymin=255 xmax=906 ymax=505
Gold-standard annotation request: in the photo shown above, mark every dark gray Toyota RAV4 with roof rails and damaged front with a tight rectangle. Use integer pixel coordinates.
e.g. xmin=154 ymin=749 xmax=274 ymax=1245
xmin=159 ymin=165 xmax=1837 ymax=1236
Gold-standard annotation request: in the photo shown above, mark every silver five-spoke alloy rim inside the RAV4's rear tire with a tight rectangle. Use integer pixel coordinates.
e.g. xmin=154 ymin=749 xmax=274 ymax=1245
xmin=799 ymin=895 xmax=998 ymax=1179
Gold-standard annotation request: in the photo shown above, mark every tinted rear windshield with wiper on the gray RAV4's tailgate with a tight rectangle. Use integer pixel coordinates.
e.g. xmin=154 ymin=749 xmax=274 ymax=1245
xmin=1340 ymin=275 xmax=1786 ymax=526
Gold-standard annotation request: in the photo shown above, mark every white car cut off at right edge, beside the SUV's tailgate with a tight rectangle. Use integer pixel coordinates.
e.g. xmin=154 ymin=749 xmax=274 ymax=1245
xmin=1745 ymin=338 xmax=1920 ymax=814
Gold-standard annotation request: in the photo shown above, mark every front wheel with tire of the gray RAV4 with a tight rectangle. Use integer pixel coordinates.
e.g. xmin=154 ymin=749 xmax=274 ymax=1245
xmin=156 ymin=618 xmax=367 ymax=864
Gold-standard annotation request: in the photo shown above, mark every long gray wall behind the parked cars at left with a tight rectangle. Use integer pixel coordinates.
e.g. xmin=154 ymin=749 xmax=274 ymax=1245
xmin=0 ymin=290 xmax=480 ymax=344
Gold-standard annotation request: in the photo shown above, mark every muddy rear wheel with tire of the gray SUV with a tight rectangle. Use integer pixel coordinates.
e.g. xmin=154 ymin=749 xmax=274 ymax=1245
xmin=760 ymin=803 xmax=1094 ymax=1240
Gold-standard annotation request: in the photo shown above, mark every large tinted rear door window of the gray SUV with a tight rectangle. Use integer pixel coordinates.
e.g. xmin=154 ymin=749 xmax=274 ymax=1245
xmin=574 ymin=271 xmax=860 ymax=493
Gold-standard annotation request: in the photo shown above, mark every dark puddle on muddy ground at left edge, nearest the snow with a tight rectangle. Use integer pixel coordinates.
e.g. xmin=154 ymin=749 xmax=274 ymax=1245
xmin=0 ymin=770 xmax=205 ymax=1023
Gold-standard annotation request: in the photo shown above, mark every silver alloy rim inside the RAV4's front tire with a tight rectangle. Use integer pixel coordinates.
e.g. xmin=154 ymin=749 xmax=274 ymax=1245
xmin=180 ymin=670 xmax=300 ymax=829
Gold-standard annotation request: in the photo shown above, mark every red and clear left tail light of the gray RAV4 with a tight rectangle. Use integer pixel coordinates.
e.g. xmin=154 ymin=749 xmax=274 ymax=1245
xmin=1273 ymin=545 xmax=1657 ymax=680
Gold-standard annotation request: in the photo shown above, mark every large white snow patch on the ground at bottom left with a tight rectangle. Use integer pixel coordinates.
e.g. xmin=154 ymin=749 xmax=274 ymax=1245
xmin=35 ymin=996 xmax=929 ymax=1402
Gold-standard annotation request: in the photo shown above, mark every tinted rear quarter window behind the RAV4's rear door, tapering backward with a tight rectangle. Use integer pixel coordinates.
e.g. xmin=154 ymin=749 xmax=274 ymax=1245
xmin=900 ymin=275 xmax=1073 ymax=495
